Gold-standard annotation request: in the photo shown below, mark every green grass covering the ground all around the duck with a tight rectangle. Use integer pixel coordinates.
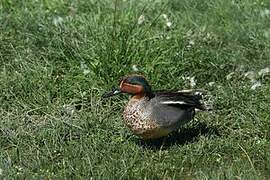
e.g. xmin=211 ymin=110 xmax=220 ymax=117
xmin=0 ymin=0 xmax=270 ymax=179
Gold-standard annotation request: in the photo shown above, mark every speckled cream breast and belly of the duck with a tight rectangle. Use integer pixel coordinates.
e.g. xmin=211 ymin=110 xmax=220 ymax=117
xmin=123 ymin=99 xmax=171 ymax=139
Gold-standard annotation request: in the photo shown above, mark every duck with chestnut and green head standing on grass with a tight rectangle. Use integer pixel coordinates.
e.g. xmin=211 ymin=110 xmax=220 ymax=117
xmin=102 ymin=74 xmax=207 ymax=140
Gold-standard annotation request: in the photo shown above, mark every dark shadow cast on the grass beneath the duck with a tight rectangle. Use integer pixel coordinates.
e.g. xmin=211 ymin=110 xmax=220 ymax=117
xmin=138 ymin=122 xmax=220 ymax=150
